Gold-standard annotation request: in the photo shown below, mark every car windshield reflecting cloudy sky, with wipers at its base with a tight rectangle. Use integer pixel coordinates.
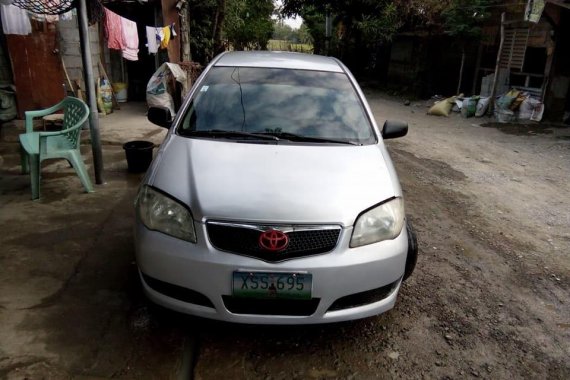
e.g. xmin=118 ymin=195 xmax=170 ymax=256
xmin=178 ymin=67 xmax=376 ymax=144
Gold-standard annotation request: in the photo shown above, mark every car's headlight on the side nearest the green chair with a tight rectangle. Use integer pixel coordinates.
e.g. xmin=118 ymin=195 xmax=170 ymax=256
xmin=136 ymin=185 xmax=196 ymax=243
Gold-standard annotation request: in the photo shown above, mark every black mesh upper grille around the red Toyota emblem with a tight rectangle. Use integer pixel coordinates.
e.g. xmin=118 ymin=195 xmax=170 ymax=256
xmin=206 ymin=222 xmax=341 ymax=262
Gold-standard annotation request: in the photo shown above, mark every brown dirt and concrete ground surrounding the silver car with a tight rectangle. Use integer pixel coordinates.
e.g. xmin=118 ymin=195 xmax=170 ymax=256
xmin=0 ymin=91 xmax=570 ymax=379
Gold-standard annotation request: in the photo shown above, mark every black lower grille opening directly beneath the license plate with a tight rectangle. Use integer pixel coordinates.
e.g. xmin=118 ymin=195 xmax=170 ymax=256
xmin=222 ymin=296 xmax=320 ymax=317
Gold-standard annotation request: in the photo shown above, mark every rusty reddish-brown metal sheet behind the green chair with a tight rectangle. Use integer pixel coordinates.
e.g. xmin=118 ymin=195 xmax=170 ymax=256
xmin=6 ymin=22 xmax=65 ymax=118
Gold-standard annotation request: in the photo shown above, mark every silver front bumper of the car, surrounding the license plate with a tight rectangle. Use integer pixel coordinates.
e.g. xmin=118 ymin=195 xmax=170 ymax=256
xmin=135 ymin=222 xmax=408 ymax=324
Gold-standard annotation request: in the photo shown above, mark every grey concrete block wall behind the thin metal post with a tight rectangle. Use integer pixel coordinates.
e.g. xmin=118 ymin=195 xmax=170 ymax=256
xmin=58 ymin=12 xmax=100 ymax=91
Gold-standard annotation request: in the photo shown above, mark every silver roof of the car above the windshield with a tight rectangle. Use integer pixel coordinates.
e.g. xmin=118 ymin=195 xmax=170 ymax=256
xmin=214 ymin=51 xmax=344 ymax=73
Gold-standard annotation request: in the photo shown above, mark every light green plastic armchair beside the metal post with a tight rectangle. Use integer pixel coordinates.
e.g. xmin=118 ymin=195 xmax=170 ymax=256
xmin=20 ymin=97 xmax=93 ymax=199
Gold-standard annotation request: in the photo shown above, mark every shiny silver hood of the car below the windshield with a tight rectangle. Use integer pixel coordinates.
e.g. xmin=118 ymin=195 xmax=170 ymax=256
xmin=148 ymin=135 xmax=401 ymax=226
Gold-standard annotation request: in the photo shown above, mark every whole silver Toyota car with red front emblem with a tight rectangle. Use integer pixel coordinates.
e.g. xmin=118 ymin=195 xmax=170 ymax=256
xmin=135 ymin=52 xmax=417 ymax=324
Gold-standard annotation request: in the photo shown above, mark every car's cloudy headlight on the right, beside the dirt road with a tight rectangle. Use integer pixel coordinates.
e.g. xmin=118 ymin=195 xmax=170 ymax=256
xmin=350 ymin=198 xmax=405 ymax=248
